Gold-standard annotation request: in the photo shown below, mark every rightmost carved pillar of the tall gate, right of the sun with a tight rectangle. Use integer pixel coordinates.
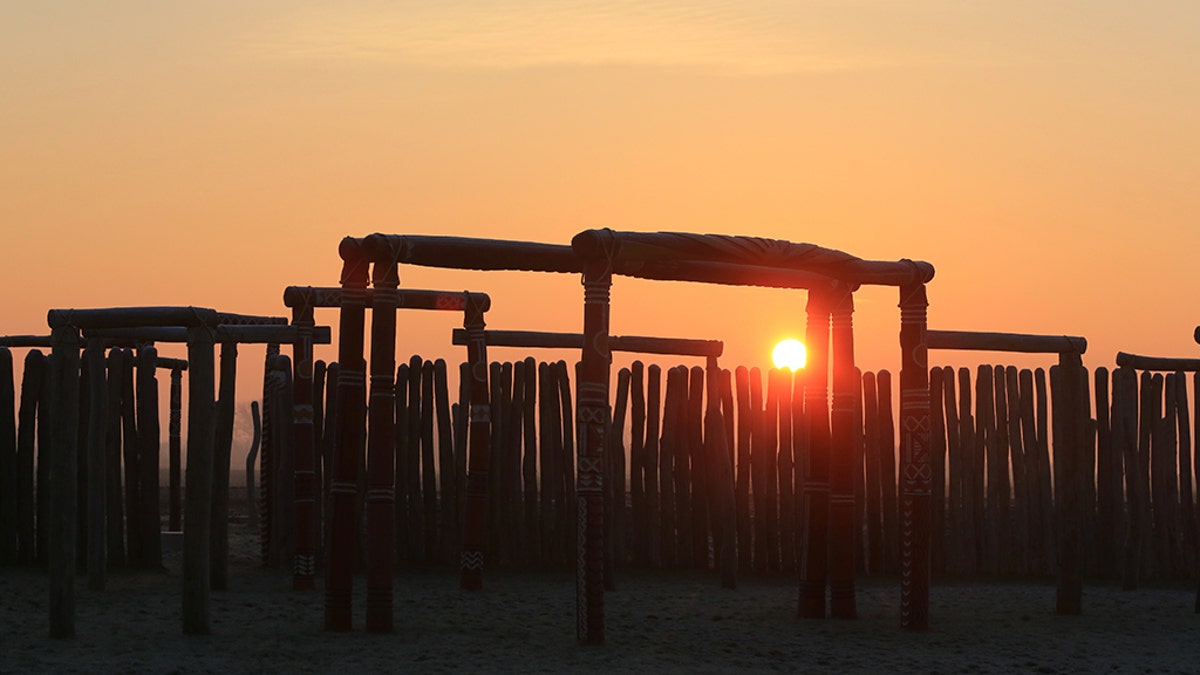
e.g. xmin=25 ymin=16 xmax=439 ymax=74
xmin=900 ymin=283 xmax=934 ymax=631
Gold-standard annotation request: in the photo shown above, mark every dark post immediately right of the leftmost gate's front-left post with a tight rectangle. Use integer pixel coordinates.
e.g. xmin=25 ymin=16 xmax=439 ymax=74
xmin=83 ymin=341 xmax=108 ymax=591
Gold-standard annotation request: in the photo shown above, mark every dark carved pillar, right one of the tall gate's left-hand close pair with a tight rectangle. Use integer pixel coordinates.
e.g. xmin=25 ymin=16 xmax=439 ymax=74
xmin=366 ymin=263 xmax=398 ymax=633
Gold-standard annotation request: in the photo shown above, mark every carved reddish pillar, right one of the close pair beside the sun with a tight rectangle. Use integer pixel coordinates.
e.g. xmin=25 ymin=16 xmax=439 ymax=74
xmin=829 ymin=288 xmax=860 ymax=619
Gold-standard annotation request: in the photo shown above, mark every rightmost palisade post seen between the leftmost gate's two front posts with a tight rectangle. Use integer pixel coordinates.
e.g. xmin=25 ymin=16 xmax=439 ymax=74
xmin=137 ymin=346 xmax=162 ymax=569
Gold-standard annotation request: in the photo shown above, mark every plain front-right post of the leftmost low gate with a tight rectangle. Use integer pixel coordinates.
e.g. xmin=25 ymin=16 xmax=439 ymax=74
xmin=181 ymin=325 xmax=216 ymax=635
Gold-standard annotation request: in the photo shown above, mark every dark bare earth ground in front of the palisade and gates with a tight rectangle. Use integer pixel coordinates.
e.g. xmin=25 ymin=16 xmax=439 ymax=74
xmin=0 ymin=525 xmax=1200 ymax=673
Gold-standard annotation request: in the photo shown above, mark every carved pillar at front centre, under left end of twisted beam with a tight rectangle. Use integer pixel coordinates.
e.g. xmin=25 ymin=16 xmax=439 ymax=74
xmin=575 ymin=259 xmax=612 ymax=645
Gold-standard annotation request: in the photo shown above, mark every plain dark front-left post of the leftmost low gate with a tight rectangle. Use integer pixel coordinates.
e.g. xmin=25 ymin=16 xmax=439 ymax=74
xmin=47 ymin=324 xmax=79 ymax=638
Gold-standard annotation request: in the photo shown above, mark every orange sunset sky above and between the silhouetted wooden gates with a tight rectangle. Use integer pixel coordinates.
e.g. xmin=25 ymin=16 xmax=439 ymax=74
xmin=0 ymin=0 xmax=1200 ymax=417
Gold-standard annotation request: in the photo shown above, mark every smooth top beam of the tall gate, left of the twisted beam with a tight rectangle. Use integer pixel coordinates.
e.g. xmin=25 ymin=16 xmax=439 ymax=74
xmin=362 ymin=233 xmax=583 ymax=274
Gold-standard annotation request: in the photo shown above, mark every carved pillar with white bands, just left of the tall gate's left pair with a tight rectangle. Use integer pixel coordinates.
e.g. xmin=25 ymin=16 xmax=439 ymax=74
xmin=292 ymin=303 xmax=317 ymax=591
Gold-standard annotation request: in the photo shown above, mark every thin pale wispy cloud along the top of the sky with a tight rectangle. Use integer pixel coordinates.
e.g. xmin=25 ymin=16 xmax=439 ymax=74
xmin=238 ymin=0 xmax=1008 ymax=73
